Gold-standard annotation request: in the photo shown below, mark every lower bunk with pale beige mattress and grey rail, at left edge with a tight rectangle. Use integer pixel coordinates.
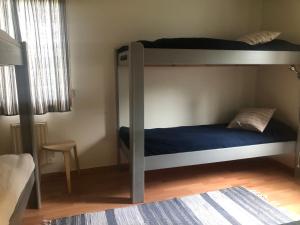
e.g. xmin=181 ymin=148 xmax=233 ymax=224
xmin=0 ymin=154 xmax=35 ymax=225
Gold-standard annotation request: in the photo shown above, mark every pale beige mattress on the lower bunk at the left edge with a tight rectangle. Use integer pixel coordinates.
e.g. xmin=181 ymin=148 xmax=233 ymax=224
xmin=0 ymin=154 xmax=35 ymax=225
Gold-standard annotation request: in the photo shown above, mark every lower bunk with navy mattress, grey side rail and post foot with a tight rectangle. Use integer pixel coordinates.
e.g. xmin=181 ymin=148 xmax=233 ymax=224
xmin=119 ymin=120 xmax=297 ymax=203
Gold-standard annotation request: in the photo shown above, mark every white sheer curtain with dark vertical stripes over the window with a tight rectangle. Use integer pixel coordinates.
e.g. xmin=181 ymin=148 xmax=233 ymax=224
xmin=0 ymin=0 xmax=71 ymax=115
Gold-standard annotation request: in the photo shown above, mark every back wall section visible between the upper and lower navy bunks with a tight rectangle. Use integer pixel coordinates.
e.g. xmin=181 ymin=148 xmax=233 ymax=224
xmin=120 ymin=66 xmax=257 ymax=128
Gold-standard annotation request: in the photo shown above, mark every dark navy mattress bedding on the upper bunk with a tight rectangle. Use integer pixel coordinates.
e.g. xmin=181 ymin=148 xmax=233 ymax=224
xmin=118 ymin=38 xmax=300 ymax=53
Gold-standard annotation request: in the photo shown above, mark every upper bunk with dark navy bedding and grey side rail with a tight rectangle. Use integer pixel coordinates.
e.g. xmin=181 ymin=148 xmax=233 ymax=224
xmin=117 ymin=38 xmax=300 ymax=66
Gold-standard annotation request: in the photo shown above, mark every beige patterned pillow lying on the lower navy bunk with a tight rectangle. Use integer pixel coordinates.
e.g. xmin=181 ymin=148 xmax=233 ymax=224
xmin=227 ymin=108 xmax=275 ymax=132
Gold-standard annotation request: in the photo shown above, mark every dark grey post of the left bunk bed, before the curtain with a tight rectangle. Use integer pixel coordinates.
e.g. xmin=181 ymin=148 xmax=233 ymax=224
xmin=16 ymin=42 xmax=41 ymax=209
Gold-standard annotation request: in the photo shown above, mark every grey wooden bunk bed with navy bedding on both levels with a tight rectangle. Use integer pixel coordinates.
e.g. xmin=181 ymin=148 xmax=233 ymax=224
xmin=115 ymin=38 xmax=300 ymax=203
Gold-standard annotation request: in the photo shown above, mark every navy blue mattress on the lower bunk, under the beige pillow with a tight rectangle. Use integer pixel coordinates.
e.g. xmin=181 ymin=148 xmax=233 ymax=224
xmin=119 ymin=120 xmax=297 ymax=156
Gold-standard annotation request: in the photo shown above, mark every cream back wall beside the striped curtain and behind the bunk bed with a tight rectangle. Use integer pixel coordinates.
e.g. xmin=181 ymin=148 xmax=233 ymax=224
xmin=0 ymin=0 xmax=262 ymax=172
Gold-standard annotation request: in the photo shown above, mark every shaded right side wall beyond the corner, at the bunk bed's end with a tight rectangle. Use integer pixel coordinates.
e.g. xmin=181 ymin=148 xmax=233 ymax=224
xmin=257 ymin=0 xmax=300 ymax=166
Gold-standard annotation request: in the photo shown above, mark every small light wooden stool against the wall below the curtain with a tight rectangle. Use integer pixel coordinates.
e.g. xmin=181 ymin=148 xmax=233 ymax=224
xmin=42 ymin=141 xmax=80 ymax=193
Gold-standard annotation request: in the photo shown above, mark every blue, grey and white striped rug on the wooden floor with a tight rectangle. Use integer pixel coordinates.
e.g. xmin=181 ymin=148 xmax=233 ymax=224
xmin=50 ymin=187 xmax=295 ymax=225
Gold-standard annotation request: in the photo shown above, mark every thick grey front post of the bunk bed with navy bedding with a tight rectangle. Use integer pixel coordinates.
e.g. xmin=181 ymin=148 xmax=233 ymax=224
xmin=129 ymin=42 xmax=145 ymax=203
